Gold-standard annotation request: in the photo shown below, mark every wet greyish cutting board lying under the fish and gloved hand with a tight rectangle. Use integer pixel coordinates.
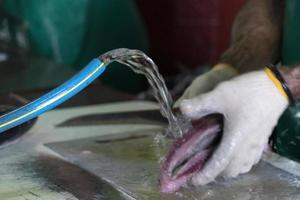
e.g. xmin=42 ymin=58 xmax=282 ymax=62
xmin=47 ymin=129 xmax=300 ymax=200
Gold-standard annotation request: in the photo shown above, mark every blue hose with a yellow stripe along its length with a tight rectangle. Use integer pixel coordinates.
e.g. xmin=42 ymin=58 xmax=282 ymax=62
xmin=0 ymin=58 xmax=107 ymax=134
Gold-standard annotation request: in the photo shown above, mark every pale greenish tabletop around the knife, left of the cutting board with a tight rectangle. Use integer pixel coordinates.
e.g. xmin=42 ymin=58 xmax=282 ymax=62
xmin=0 ymin=101 xmax=157 ymax=200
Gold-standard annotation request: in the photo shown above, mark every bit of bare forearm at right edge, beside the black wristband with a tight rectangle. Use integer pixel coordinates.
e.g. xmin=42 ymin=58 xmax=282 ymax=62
xmin=279 ymin=66 xmax=300 ymax=100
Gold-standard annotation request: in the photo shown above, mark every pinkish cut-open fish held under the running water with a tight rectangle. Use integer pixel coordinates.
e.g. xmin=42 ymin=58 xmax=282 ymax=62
xmin=159 ymin=113 xmax=223 ymax=193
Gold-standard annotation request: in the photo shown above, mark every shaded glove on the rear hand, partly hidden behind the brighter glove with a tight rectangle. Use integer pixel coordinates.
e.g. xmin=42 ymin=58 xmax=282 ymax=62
xmin=174 ymin=63 xmax=238 ymax=107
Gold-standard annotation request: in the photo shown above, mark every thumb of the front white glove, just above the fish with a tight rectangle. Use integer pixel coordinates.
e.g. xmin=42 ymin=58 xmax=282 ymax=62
xmin=180 ymin=92 xmax=220 ymax=119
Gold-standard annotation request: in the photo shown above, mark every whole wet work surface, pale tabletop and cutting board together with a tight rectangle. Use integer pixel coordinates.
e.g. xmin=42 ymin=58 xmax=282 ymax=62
xmin=0 ymin=102 xmax=300 ymax=200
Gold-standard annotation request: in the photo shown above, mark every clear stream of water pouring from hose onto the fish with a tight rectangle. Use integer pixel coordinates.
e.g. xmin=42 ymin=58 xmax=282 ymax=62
xmin=99 ymin=48 xmax=189 ymax=138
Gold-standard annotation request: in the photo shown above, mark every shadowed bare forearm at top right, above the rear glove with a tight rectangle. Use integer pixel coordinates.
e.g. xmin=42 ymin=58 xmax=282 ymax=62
xmin=220 ymin=0 xmax=283 ymax=72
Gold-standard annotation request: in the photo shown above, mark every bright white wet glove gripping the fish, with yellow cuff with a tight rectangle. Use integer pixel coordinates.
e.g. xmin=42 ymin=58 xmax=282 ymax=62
xmin=180 ymin=71 xmax=288 ymax=185
